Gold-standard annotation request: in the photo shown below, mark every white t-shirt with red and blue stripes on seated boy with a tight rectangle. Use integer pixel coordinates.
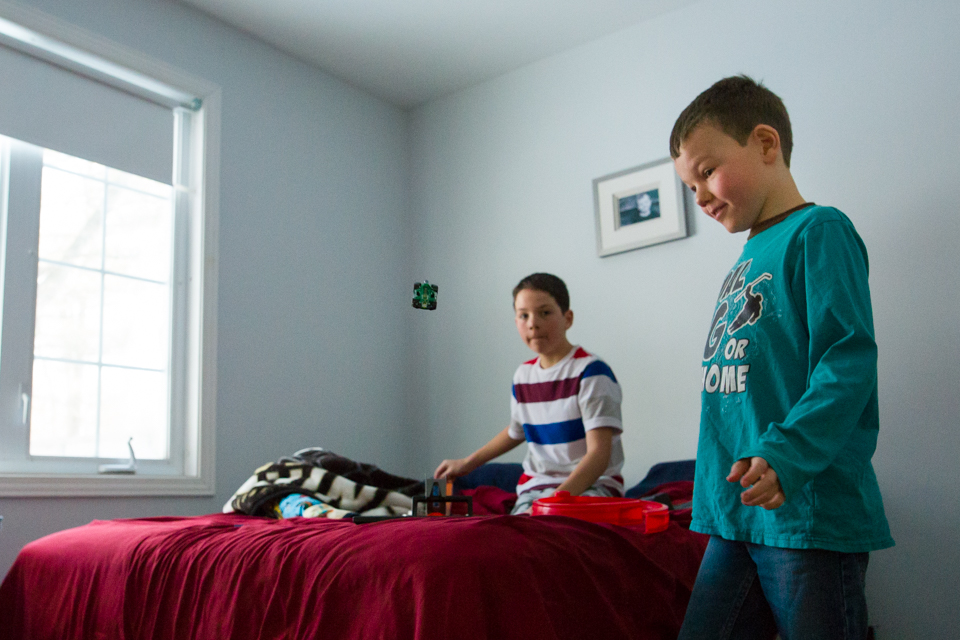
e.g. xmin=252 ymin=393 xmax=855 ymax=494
xmin=508 ymin=347 xmax=623 ymax=495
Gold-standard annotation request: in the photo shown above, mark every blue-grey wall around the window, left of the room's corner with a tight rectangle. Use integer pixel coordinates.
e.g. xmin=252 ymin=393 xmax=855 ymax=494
xmin=0 ymin=0 xmax=414 ymax=575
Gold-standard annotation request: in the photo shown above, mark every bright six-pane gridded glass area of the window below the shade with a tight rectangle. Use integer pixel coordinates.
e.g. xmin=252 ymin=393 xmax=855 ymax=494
xmin=30 ymin=150 xmax=173 ymax=459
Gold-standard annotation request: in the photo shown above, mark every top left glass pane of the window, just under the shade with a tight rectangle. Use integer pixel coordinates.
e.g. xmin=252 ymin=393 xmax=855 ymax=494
xmin=39 ymin=167 xmax=103 ymax=269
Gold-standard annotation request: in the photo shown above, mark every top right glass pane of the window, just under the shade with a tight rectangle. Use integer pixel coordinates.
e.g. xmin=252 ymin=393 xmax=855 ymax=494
xmin=104 ymin=181 xmax=173 ymax=282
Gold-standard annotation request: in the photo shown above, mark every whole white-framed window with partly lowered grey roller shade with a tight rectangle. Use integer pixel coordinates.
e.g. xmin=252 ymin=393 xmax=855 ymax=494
xmin=0 ymin=7 xmax=219 ymax=495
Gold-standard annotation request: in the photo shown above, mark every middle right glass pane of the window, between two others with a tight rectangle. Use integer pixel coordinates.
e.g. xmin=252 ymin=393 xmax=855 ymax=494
xmin=103 ymin=274 xmax=170 ymax=370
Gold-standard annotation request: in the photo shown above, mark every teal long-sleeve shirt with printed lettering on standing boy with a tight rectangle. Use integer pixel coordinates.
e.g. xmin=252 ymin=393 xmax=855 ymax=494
xmin=691 ymin=205 xmax=893 ymax=552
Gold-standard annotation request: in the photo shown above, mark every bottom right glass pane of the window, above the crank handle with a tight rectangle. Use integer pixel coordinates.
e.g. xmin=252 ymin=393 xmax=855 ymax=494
xmin=100 ymin=367 xmax=167 ymax=460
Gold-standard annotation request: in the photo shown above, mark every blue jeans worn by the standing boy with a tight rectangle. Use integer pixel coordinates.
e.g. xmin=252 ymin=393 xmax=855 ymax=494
xmin=680 ymin=536 xmax=869 ymax=640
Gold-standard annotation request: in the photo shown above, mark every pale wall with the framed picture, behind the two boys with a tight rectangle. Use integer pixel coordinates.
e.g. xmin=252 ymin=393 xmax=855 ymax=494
xmin=411 ymin=0 xmax=960 ymax=639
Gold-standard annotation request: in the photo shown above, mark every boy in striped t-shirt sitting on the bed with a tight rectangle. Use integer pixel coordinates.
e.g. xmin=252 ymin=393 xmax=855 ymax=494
xmin=434 ymin=273 xmax=624 ymax=514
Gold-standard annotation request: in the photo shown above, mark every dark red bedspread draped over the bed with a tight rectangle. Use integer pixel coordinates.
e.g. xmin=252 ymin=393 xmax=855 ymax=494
xmin=0 ymin=514 xmax=705 ymax=640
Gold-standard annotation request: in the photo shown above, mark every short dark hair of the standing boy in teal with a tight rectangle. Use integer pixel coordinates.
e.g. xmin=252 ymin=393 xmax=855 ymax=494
xmin=670 ymin=75 xmax=793 ymax=168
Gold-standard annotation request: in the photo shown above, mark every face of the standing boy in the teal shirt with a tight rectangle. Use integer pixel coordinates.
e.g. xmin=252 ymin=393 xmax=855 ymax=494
xmin=673 ymin=123 xmax=768 ymax=233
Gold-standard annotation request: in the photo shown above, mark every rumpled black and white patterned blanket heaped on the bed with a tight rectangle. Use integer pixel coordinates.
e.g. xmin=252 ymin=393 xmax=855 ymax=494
xmin=223 ymin=447 xmax=423 ymax=518
